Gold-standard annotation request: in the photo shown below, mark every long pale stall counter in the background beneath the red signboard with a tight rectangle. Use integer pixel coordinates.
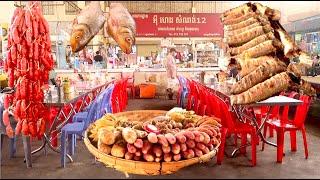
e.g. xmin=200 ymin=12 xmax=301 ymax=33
xmin=55 ymin=67 xmax=220 ymax=96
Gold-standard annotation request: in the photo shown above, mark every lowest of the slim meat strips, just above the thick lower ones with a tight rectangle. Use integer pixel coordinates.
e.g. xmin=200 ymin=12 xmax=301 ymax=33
xmin=229 ymin=32 xmax=275 ymax=56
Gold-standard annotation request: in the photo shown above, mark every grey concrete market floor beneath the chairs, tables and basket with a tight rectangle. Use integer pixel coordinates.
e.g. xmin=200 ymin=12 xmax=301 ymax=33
xmin=0 ymin=99 xmax=320 ymax=179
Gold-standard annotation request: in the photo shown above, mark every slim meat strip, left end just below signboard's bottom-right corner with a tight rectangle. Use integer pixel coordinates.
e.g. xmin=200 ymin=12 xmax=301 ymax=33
xmin=225 ymin=25 xmax=273 ymax=46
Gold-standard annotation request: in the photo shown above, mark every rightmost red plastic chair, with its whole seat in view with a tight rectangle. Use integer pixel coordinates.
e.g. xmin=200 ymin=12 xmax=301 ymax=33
xmin=266 ymin=95 xmax=311 ymax=163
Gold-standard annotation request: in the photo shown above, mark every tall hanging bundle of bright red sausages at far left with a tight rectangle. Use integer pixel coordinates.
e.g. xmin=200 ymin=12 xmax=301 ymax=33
xmin=3 ymin=1 xmax=53 ymax=137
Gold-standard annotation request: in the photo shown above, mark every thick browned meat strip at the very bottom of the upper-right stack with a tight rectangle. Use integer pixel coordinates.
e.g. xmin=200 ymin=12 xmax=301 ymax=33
xmin=230 ymin=72 xmax=291 ymax=105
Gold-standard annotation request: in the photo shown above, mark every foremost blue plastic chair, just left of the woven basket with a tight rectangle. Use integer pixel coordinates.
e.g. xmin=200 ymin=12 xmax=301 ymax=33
xmin=60 ymin=98 xmax=99 ymax=167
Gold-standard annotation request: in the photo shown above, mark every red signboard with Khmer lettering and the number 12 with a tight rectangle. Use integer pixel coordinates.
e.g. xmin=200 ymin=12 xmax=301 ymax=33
xmin=132 ymin=13 xmax=223 ymax=37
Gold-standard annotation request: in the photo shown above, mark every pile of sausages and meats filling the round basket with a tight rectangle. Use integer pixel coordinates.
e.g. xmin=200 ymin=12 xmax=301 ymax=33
xmin=89 ymin=111 xmax=221 ymax=162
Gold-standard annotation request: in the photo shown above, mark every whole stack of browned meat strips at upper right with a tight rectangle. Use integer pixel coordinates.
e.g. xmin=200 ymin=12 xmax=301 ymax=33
xmin=221 ymin=2 xmax=315 ymax=104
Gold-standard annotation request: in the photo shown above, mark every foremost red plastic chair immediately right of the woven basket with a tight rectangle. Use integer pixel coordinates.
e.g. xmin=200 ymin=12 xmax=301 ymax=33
xmin=217 ymin=97 xmax=258 ymax=166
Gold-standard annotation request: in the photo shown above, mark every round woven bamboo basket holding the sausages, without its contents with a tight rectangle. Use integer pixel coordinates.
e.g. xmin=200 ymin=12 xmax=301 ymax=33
xmin=84 ymin=110 xmax=219 ymax=176
